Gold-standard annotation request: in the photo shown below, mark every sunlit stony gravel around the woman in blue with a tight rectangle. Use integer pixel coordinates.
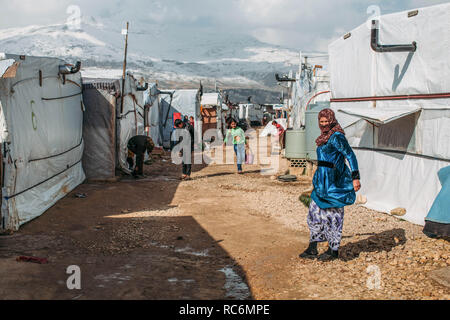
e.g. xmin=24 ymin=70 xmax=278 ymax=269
xmin=186 ymin=166 xmax=450 ymax=300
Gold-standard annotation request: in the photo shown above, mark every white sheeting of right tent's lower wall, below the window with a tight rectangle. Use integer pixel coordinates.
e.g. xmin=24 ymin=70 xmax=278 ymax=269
xmin=355 ymin=150 xmax=448 ymax=225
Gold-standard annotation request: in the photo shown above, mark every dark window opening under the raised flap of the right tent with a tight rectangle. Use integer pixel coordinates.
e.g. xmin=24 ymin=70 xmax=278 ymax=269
xmin=374 ymin=114 xmax=418 ymax=152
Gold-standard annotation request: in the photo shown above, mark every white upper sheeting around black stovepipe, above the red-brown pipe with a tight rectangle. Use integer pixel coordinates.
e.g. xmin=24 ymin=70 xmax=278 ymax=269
xmin=329 ymin=3 xmax=450 ymax=101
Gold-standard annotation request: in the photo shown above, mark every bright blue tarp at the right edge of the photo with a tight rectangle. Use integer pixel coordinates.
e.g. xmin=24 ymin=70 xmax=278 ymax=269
xmin=426 ymin=166 xmax=450 ymax=224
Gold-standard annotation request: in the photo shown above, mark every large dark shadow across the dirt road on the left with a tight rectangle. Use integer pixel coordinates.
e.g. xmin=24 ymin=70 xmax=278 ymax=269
xmin=0 ymin=156 xmax=253 ymax=300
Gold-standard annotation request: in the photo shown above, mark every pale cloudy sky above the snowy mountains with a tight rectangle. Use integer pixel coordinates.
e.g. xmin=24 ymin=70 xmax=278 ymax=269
xmin=0 ymin=0 xmax=449 ymax=51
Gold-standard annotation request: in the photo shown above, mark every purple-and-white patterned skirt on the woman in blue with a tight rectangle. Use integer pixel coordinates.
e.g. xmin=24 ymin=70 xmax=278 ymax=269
xmin=308 ymin=200 xmax=344 ymax=251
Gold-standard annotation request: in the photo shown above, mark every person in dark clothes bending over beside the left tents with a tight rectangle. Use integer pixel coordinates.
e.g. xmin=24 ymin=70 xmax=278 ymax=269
xmin=127 ymin=136 xmax=155 ymax=178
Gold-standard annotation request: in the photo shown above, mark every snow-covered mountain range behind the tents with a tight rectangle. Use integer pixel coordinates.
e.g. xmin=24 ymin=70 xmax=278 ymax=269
xmin=0 ymin=17 xmax=299 ymax=89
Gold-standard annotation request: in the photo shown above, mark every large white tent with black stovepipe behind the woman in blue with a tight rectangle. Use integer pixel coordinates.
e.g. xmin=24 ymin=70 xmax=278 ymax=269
xmin=329 ymin=4 xmax=450 ymax=225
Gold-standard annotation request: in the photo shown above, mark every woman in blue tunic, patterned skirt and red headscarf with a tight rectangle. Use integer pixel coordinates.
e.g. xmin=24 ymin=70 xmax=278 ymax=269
xmin=300 ymin=109 xmax=361 ymax=261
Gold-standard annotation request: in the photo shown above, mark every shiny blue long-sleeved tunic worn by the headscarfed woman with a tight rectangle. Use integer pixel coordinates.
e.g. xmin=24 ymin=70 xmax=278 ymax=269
xmin=311 ymin=132 xmax=360 ymax=209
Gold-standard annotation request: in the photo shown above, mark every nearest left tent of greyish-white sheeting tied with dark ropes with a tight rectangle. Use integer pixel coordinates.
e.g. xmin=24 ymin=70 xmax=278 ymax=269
xmin=0 ymin=55 xmax=85 ymax=231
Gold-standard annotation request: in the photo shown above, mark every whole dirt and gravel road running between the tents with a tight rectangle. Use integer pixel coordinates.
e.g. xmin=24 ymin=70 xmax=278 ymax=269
xmin=0 ymin=151 xmax=450 ymax=300
